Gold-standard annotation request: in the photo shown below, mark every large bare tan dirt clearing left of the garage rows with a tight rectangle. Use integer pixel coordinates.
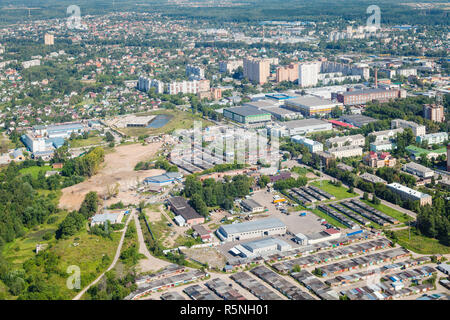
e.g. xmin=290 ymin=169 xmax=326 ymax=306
xmin=59 ymin=142 xmax=164 ymax=210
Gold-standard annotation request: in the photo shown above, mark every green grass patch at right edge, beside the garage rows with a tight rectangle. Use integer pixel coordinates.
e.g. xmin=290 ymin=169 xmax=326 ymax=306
xmin=395 ymin=228 xmax=450 ymax=254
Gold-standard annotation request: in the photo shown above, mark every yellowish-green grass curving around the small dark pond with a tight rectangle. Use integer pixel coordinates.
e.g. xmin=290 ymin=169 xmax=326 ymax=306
xmin=120 ymin=110 xmax=212 ymax=137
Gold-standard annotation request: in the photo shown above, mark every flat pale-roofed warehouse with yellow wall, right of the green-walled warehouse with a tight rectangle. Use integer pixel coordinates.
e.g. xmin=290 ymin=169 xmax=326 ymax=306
xmin=284 ymin=96 xmax=344 ymax=116
